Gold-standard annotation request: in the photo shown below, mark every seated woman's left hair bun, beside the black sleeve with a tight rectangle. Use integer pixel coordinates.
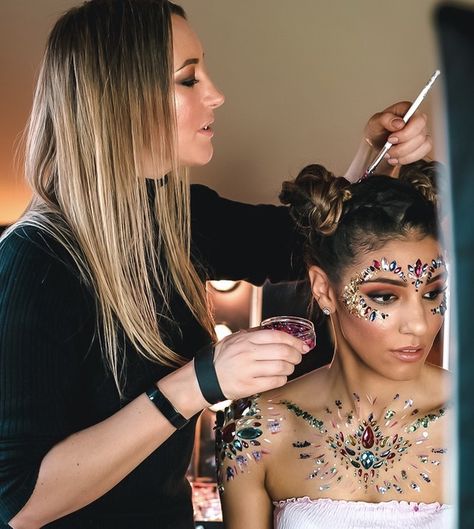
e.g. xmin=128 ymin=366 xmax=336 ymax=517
xmin=279 ymin=164 xmax=351 ymax=235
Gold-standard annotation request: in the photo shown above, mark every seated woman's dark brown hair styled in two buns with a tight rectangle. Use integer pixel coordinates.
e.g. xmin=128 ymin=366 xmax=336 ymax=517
xmin=280 ymin=160 xmax=440 ymax=284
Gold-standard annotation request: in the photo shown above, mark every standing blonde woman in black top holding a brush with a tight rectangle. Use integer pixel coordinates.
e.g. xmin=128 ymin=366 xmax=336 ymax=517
xmin=0 ymin=0 xmax=431 ymax=529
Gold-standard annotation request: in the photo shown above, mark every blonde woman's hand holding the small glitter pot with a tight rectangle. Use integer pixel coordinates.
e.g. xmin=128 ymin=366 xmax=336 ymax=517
xmin=214 ymin=328 xmax=310 ymax=399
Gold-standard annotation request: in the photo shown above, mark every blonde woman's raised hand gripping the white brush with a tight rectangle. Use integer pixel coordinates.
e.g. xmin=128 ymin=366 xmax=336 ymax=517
xmin=364 ymin=101 xmax=433 ymax=165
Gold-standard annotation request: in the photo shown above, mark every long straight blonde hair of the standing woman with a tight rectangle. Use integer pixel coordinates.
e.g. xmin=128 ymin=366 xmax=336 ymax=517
xmin=14 ymin=0 xmax=213 ymax=391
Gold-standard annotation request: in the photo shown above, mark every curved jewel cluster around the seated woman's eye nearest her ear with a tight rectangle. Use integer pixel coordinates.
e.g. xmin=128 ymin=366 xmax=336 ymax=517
xmin=342 ymin=257 xmax=407 ymax=321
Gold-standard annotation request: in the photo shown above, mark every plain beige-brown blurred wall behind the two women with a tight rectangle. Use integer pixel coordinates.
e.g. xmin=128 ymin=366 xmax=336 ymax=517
xmin=0 ymin=0 xmax=468 ymax=225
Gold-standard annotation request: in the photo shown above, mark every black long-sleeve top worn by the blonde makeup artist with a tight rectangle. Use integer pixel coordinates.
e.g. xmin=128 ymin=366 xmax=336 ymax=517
xmin=0 ymin=185 xmax=302 ymax=529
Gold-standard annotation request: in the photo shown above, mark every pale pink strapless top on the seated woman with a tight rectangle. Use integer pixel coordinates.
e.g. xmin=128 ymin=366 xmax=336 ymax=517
xmin=273 ymin=497 xmax=454 ymax=529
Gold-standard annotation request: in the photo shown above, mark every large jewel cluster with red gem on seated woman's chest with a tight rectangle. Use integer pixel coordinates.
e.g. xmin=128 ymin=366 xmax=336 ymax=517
xmin=282 ymin=395 xmax=447 ymax=494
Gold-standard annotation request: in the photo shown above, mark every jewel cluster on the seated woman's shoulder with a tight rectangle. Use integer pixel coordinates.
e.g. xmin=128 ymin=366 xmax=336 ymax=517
xmin=216 ymin=395 xmax=268 ymax=492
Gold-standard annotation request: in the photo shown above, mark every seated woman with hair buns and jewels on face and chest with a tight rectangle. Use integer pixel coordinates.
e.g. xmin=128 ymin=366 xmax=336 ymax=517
xmin=216 ymin=162 xmax=451 ymax=529
